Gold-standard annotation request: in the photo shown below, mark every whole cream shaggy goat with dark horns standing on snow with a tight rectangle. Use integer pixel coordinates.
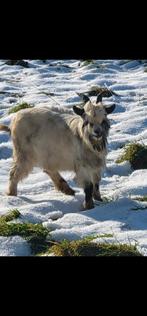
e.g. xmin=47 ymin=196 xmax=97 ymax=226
xmin=0 ymin=96 xmax=115 ymax=209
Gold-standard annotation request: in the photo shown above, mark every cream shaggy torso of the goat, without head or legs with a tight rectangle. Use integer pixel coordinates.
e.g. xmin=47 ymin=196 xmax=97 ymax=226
xmin=11 ymin=108 xmax=106 ymax=181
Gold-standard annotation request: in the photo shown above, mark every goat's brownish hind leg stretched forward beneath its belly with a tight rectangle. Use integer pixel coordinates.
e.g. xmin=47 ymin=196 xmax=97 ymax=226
xmin=44 ymin=169 xmax=75 ymax=195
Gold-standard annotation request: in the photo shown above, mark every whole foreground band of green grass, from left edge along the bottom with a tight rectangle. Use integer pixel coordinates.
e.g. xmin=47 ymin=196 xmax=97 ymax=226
xmin=0 ymin=209 xmax=141 ymax=257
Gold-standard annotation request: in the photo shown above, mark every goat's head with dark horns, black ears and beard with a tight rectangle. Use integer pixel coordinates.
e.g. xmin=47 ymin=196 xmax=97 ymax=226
xmin=73 ymin=95 xmax=115 ymax=147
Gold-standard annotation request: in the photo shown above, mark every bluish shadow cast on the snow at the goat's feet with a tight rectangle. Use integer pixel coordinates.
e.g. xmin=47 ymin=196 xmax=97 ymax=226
xmin=21 ymin=194 xmax=147 ymax=231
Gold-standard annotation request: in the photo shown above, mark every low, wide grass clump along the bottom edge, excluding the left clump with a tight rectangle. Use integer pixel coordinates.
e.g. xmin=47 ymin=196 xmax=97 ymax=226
xmin=41 ymin=238 xmax=141 ymax=257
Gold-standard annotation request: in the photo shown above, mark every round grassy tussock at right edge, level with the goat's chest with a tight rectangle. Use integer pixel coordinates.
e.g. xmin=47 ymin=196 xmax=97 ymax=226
xmin=116 ymin=143 xmax=147 ymax=170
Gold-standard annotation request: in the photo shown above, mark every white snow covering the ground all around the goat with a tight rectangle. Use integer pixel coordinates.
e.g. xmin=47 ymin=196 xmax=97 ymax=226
xmin=0 ymin=60 xmax=147 ymax=256
